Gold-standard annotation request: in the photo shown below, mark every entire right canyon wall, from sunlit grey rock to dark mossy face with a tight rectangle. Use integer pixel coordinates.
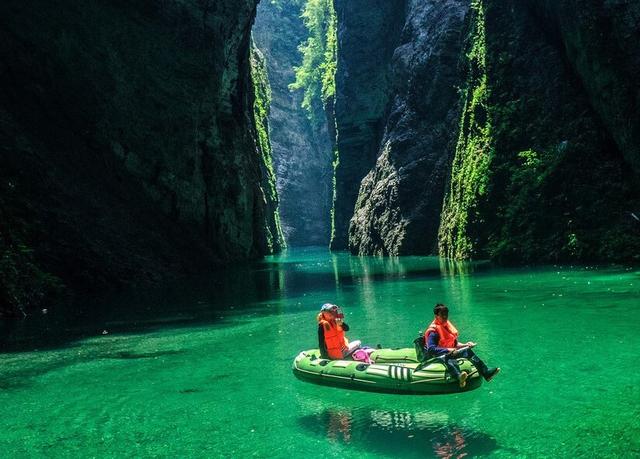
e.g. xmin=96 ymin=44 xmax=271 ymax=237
xmin=336 ymin=0 xmax=640 ymax=263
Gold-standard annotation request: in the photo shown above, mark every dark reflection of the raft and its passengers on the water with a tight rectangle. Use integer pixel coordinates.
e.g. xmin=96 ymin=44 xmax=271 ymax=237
xmin=300 ymin=408 xmax=498 ymax=459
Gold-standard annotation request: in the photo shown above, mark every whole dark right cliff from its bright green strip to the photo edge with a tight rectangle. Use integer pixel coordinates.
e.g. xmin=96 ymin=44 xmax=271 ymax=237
xmin=440 ymin=0 xmax=640 ymax=262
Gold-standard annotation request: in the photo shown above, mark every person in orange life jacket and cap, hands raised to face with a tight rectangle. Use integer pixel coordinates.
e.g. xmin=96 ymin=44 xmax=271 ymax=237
xmin=318 ymin=303 xmax=360 ymax=359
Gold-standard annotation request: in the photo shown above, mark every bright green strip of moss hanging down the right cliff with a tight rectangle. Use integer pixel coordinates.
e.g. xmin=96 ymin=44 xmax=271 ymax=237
xmin=438 ymin=0 xmax=492 ymax=259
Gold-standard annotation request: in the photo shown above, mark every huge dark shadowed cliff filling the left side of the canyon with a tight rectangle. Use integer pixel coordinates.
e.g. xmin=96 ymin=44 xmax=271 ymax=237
xmin=0 ymin=0 xmax=278 ymax=316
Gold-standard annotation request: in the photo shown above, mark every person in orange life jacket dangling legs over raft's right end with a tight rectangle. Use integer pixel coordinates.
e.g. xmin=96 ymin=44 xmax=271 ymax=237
xmin=424 ymin=304 xmax=500 ymax=387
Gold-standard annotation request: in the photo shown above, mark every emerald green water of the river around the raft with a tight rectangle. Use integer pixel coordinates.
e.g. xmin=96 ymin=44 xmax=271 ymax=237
xmin=0 ymin=250 xmax=640 ymax=458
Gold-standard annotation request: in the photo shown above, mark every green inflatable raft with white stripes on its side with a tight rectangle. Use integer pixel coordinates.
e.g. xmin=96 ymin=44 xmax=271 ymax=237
xmin=293 ymin=348 xmax=482 ymax=395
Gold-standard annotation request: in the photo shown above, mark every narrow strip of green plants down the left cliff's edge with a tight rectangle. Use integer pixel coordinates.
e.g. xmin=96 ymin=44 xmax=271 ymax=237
xmin=251 ymin=44 xmax=285 ymax=253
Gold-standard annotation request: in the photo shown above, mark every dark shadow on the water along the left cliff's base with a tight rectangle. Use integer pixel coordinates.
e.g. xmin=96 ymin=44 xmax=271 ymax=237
xmin=0 ymin=258 xmax=282 ymax=352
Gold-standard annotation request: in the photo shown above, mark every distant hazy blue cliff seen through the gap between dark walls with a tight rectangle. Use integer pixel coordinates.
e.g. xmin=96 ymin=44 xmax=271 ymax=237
xmin=253 ymin=0 xmax=333 ymax=246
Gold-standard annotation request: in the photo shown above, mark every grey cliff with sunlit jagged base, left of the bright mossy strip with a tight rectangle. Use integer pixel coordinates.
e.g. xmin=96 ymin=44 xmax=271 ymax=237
xmin=348 ymin=0 xmax=469 ymax=255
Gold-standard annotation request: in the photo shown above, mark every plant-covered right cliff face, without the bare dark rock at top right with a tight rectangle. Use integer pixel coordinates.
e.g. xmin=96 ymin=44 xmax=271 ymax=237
xmin=439 ymin=0 xmax=640 ymax=263
